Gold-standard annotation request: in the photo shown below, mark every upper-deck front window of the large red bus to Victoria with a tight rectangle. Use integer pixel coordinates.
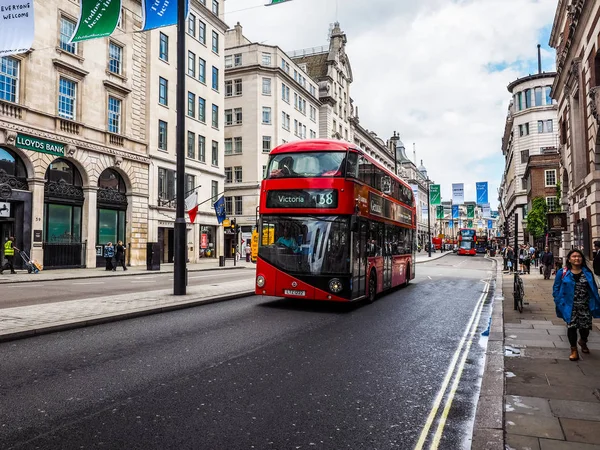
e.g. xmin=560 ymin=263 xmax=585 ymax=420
xmin=267 ymin=152 xmax=346 ymax=178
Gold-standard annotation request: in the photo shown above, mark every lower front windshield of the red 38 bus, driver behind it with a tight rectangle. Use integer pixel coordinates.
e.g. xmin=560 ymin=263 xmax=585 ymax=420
xmin=258 ymin=216 xmax=350 ymax=275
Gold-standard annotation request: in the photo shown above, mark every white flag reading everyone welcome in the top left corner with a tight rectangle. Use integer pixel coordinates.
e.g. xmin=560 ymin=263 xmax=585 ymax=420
xmin=0 ymin=0 xmax=34 ymax=56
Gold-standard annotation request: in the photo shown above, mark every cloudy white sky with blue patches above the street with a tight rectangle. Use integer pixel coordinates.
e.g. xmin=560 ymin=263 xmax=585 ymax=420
xmin=225 ymin=0 xmax=558 ymax=209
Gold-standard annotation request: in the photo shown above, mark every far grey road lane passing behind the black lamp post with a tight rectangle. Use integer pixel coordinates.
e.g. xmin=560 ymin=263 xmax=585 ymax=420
xmin=0 ymin=268 xmax=255 ymax=309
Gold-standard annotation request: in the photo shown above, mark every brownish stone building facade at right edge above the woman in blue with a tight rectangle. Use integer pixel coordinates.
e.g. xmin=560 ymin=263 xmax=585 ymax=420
xmin=550 ymin=0 xmax=600 ymax=256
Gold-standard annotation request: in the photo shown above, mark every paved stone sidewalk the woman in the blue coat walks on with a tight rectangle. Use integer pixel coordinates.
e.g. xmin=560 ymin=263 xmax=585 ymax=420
xmin=497 ymin=264 xmax=600 ymax=450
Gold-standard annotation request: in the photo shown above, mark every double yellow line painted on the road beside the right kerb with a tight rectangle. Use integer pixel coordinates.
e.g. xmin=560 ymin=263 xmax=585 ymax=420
xmin=415 ymin=280 xmax=490 ymax=450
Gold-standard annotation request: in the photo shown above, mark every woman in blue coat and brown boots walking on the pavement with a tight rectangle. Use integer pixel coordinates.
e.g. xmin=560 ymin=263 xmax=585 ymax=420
xmin=552 ymin=250 xmax=600 ymax=361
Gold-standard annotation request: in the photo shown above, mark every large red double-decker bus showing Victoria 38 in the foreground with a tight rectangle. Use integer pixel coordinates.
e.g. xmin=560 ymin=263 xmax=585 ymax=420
xmin=256 ymin=140 xmax=416 ymax=302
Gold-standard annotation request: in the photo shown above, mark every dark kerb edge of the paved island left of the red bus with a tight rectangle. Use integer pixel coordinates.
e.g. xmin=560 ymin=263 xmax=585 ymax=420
xmin=0 ymin=290 xmax=255 ymax=342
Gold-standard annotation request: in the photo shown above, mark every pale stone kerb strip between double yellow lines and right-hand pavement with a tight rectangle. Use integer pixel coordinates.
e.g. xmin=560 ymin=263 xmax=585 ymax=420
xmin=471 ymin=256 xmax=505 ymax=450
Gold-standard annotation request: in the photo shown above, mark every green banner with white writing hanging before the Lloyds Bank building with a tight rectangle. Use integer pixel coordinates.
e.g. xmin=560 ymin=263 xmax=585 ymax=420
xmin=71 ymin=0 xmax=121 ymax=42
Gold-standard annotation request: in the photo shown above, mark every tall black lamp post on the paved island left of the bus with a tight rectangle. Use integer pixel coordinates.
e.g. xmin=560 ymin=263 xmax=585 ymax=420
xmin=173 ymin=0 xmax=187 ymax=295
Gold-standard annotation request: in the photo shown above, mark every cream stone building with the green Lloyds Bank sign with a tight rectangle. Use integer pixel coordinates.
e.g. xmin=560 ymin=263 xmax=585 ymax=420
xmin=0 ymin=0 xmax=150 ymax=268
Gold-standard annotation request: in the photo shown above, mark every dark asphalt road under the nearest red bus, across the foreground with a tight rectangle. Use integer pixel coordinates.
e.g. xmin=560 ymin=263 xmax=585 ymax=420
xmin=0 ymin=255 xmax=492 ymax=450
